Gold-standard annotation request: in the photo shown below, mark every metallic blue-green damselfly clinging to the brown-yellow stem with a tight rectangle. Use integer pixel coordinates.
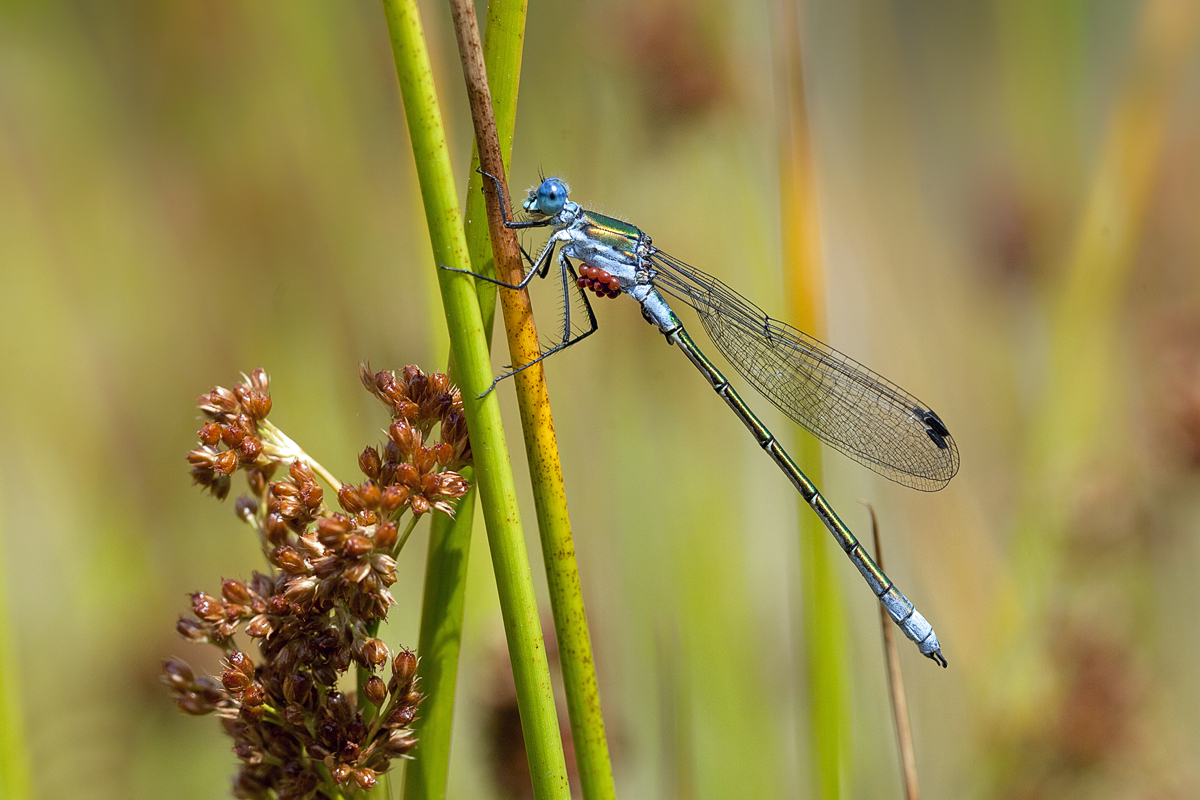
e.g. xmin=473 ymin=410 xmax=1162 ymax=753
xmin=453 ymin=173 xmax=959 ymax=667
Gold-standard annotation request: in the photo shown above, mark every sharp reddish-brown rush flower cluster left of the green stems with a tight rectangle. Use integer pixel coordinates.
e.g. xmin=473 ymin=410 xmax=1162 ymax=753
xmin=163 ymin=367 xmax=470 ymax=800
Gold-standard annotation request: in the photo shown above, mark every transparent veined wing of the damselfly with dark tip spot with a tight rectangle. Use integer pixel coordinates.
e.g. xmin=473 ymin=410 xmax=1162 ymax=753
xmin=650 ymin=251 xmax=959 ymax=492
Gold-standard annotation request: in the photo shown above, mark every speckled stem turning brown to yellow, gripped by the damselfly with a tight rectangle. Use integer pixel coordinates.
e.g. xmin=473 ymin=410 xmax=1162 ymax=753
xmin=450 ymin=0 xmax=616 ymax=800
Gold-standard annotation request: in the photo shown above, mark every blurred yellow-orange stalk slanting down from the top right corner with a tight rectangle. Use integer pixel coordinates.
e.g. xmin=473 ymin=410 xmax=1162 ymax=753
xmin=989 ymin=0 xmax=1200 ymax=758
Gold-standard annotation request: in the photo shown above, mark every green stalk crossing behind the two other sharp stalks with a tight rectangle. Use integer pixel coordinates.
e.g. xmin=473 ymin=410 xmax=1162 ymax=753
xmin=404 ymin=0 xmax=526 ymax=800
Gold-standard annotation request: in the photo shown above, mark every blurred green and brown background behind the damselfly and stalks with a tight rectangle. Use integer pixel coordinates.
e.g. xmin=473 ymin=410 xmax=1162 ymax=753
xmin=0 ymin=0 xmax=1200 ymax=800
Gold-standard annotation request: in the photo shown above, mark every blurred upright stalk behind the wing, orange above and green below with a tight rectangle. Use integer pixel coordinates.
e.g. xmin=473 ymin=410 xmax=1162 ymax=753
xmin=775 ymin=0 xmax=852 ymax=800
